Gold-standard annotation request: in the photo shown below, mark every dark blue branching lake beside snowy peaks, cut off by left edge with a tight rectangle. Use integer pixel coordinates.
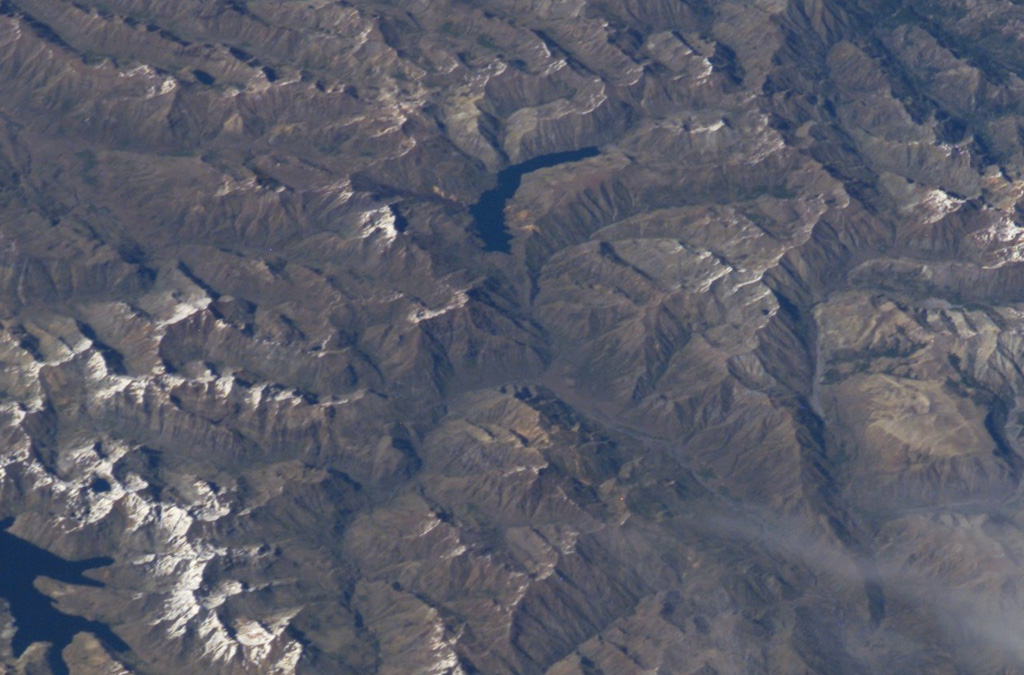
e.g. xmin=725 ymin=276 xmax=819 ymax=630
xmin=0 ymin=519 xmax=128 ymax=675
